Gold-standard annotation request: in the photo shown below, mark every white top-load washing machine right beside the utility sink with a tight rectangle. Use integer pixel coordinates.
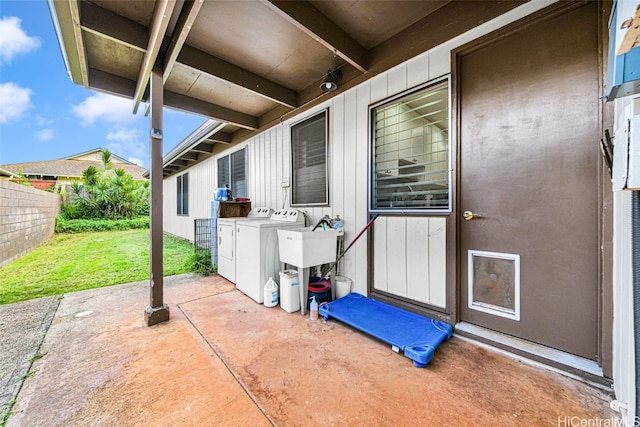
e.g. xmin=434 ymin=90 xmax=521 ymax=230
xmin=236 ymin=209 xmax=305 ymax=304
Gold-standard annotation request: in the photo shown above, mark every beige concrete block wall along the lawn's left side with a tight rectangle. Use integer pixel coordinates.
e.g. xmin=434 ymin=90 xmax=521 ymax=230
xmin=0 ymin=179 xmax=62 ymax=267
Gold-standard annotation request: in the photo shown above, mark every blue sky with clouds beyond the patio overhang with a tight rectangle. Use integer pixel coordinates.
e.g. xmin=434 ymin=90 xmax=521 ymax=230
xmin=0 ymin=0 xmax=205 ymax=168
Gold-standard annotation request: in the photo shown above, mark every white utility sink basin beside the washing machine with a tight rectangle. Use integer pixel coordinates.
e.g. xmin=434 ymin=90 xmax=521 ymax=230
xmin=278 ymin=227 xmax=339 ymax=268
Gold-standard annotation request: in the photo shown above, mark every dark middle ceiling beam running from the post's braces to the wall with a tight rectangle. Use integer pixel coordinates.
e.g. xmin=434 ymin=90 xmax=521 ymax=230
xmin=178 ymin=46 xmax=298 ymax=108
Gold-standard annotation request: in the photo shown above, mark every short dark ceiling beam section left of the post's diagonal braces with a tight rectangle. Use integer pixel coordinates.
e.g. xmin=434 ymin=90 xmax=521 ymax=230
xmin=81 ymin=2 xmax=149 ymax=52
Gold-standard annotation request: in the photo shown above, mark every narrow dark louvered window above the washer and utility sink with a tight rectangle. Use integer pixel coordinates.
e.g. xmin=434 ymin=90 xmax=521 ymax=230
xmin=291 ymin=110 xmax=329 ymax=206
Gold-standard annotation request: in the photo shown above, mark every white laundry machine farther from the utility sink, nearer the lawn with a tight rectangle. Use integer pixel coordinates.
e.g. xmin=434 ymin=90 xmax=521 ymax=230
xmin=217 ymin=208 xmax=273 ymax=283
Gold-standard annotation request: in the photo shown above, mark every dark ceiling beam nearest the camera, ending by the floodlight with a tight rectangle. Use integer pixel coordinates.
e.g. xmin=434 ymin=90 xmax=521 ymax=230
xmin=266 ymin=0 xmax=364 ymax=73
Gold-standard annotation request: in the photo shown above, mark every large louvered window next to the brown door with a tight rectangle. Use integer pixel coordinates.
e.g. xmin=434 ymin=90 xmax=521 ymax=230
xmin=370 ymin=81 xmax=449 ymax=211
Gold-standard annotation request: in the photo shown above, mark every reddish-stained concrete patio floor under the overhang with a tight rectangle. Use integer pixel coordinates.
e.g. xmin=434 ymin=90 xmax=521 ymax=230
xmin=7 ymin=275 xmax=614 ymax=427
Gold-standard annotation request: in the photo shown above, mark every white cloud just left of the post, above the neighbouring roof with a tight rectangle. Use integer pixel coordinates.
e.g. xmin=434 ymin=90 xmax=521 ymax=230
xmin=71 ymin=93 xmax=140 ymax=125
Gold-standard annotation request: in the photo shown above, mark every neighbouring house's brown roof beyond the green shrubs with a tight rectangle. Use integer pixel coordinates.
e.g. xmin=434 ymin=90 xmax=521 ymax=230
xmin=0 ymin=149 xmax=145 ymax=179
